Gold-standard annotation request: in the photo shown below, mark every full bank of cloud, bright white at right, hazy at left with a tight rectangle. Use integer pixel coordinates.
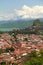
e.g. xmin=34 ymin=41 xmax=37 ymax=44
xmin=0 ymin=5 xmax=43 ymax=20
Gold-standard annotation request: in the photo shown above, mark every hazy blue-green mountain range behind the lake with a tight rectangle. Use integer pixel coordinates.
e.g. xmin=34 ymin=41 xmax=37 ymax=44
xmin=0 ymin=20 xmax=33 ymax=29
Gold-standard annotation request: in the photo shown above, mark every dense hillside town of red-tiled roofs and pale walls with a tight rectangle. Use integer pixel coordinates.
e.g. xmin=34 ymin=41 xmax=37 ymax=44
xmin=0 ymin=33 xmax=43 ymax=65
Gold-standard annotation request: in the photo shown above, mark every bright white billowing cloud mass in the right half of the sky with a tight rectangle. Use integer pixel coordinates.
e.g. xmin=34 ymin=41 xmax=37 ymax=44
xmin=16 ymin=5 xmax=43 ymax=18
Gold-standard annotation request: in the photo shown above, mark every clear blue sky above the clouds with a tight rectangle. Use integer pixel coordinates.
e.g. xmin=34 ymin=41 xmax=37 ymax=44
xmin=0 ymin=0 xmax=43 ymax=20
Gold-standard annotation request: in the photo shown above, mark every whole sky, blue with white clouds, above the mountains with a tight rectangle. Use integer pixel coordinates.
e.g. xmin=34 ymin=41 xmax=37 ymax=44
xmin=0 ymin=0 xmax=43 ymax=20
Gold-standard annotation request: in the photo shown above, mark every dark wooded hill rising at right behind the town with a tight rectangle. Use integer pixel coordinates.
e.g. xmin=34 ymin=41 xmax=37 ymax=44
xmin=9 ymin=19 xmax=43 ymax=34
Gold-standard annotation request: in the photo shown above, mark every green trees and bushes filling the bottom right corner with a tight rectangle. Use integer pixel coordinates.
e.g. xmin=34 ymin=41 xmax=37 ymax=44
xmin=23 ymin=49 xmax=43 ymax=65
